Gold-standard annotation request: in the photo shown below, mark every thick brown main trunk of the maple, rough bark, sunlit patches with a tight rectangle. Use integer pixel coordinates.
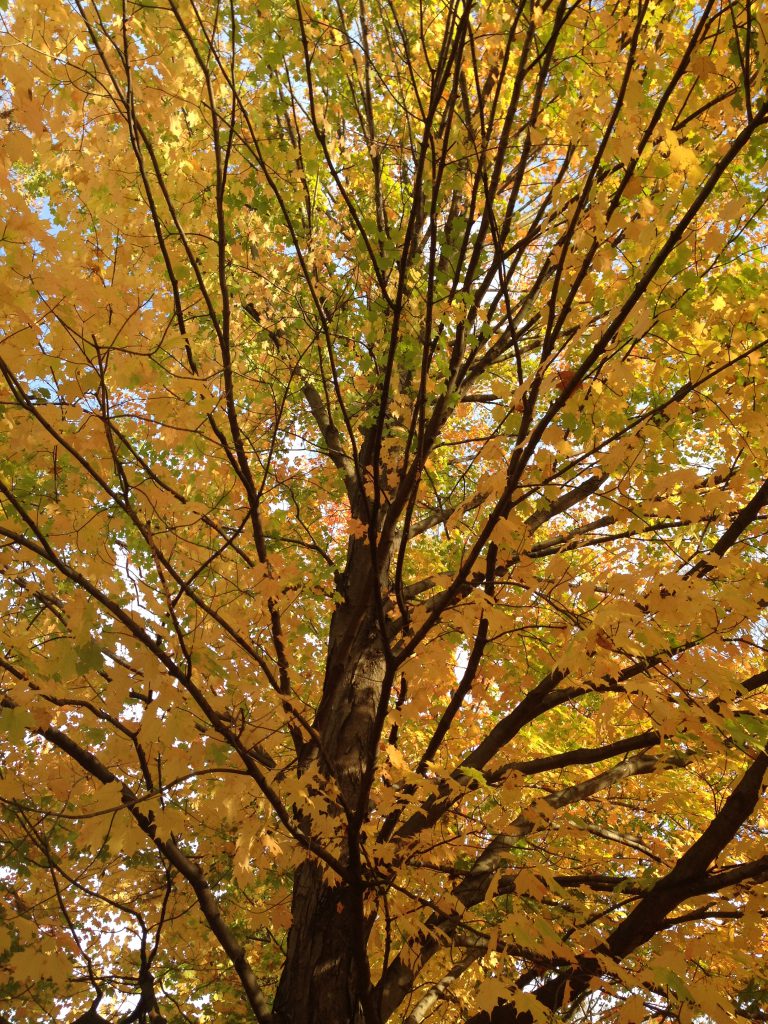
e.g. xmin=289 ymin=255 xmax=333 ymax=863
xmin=274 ymin=541 xmax=386 ymax=1024
